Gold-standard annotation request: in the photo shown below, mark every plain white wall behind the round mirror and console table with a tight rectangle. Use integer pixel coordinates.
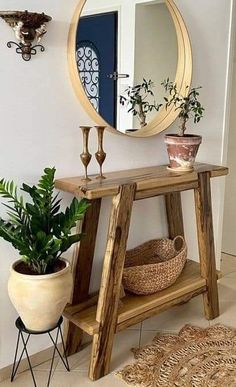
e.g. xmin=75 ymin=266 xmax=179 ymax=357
xmin=0 ymin=0 xmax=230 ymax=368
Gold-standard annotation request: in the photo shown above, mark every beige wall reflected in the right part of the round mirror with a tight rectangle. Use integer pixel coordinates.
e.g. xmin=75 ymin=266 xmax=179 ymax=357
xmin=133 ymin=3 xmax=178 ymax=128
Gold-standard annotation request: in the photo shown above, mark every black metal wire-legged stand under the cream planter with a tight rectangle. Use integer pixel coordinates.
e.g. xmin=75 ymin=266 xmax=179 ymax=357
xmin=11 ymin=317 xmax=70 ymax=387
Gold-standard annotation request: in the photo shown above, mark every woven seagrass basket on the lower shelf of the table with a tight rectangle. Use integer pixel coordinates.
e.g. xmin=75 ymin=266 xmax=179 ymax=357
xmin=123 ymin=236 xmax=187 ymax=295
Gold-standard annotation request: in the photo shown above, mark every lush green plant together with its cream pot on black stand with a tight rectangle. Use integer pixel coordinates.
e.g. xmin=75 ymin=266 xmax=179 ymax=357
xmin=0 ymin=168 xmax=89 ymax=331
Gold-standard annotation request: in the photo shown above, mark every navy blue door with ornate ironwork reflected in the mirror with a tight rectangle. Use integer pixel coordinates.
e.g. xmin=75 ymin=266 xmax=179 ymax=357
xmin=76 ymin=12 xmax=118 ymax=127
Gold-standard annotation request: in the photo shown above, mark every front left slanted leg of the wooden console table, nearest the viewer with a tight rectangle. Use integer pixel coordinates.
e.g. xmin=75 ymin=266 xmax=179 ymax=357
xmin=89 ymin=184 xmax=136 ymax=380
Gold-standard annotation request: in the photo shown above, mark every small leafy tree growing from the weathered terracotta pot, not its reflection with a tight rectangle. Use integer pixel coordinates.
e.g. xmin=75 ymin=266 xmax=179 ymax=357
xmin=162 ymin=78 xmax=205 ymax=136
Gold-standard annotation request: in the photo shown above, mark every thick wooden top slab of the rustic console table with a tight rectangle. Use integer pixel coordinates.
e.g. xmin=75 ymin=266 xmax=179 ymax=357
xmin=55 ymin=163 xmax=228 ymax=200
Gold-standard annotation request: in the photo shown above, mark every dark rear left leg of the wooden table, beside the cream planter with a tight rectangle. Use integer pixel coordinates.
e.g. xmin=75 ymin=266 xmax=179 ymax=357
xmin=64 ymin=199 xmax=101 ymax=356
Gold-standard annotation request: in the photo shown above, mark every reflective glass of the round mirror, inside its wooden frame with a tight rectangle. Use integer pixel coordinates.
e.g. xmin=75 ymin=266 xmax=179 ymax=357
xmin=76 ymin=0 xmax=178 ymax=133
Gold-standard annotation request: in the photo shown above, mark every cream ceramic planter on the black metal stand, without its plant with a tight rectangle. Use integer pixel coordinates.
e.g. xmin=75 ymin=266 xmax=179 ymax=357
xmin=8 ymin=259 xmax=72 ymax=331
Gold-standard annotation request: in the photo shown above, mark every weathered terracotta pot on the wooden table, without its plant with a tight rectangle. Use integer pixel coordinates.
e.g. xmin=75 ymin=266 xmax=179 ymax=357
xmin=165 ymin=134 xmax=202 ymax=172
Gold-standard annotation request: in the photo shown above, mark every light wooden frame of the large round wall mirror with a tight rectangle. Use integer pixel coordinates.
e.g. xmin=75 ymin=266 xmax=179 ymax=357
xmin=68 ymin=0 xmax=193 ymax=137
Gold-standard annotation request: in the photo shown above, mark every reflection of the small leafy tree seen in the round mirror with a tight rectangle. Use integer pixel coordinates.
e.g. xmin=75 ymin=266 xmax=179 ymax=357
xmin=120 ymin=78 xmax=162 ymax=128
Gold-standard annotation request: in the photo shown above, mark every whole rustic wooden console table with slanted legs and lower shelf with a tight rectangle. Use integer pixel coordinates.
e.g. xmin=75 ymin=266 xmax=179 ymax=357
xmin=56 ymin=164 xmax=228 ymax=380
